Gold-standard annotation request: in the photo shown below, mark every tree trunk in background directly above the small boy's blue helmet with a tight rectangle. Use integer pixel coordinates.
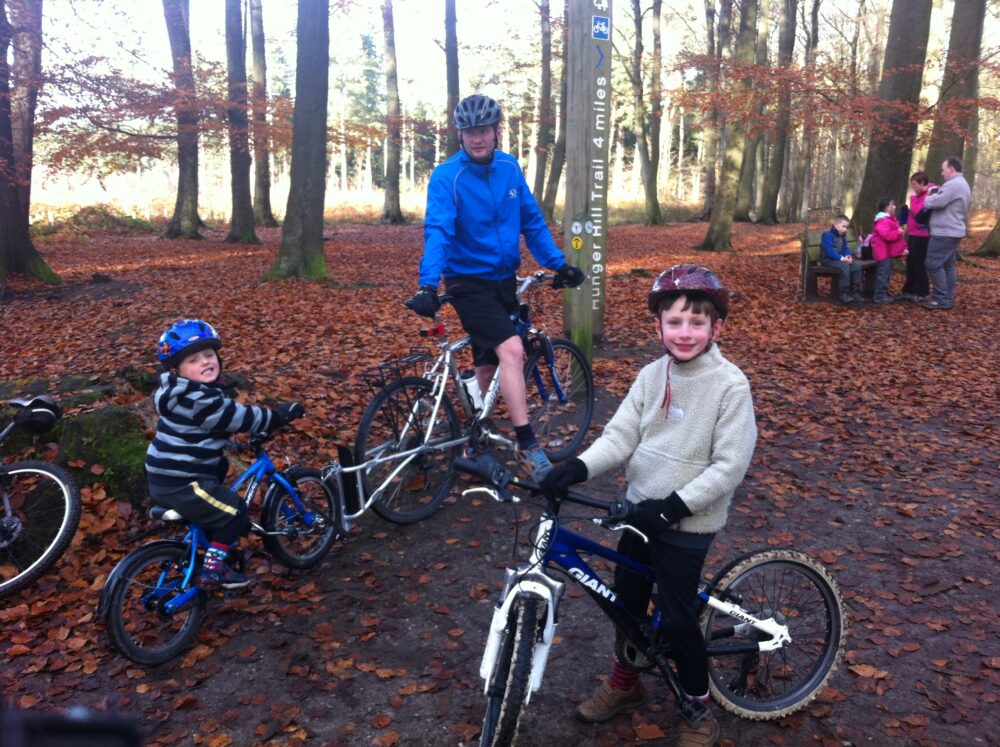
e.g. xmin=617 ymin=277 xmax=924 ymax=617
xmin=163 ymin=0 xmax=201 ymax=239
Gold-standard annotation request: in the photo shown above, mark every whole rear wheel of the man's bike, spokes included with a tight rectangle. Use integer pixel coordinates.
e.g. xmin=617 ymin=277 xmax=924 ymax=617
xmin=354 ymin=377 xmax=462 ymax=524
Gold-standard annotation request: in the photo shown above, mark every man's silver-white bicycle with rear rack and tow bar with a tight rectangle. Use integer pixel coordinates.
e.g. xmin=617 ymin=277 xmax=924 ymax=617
xmin=327 ymin=271 xmax=594 ymax=524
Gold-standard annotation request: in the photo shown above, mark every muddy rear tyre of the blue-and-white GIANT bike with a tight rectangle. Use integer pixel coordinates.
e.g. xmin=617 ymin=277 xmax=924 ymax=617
xmin=701 ymin=550 xmax=847 ymax=721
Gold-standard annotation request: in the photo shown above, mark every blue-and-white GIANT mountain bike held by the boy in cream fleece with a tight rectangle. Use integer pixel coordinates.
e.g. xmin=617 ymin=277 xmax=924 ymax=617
xmin=455 ymin=456 xmax=846 ymax=747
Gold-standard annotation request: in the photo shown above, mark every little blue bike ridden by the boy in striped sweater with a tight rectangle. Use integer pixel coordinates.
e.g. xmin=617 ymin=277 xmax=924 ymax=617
xmin=98 ymin=434 xmax=342 ymax=665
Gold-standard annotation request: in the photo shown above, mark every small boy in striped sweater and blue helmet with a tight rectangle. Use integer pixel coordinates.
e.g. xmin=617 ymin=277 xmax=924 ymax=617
xmin=146 ymin=319 xmax=305 ymax=589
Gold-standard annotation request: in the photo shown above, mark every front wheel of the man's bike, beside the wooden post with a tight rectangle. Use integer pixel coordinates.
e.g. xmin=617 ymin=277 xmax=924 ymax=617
xmin=524 ymin=338 xmax=594 ymax=461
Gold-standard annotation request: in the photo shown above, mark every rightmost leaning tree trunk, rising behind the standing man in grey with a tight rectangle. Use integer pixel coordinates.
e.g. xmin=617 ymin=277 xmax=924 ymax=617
xmin=924 ymin=0 xmax=986 ymax=177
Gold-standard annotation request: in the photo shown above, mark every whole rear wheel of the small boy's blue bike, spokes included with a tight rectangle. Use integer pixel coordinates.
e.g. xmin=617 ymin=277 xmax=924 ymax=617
xmin=105 ymin=541 xmax=207 ymax=665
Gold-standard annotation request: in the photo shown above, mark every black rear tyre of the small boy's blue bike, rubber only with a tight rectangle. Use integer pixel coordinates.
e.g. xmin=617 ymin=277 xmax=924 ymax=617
xmin=105 ymin=542 xmax=208 ymax=666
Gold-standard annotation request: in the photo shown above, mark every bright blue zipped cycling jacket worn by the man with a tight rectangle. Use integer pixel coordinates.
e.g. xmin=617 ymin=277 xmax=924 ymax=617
xmin=420 ymin=150 xmax=566 ymax=287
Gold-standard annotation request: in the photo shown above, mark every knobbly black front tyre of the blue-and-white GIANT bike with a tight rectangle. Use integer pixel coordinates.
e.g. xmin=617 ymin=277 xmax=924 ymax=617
xmin=479 ymin=596 xmax=545 ymax=747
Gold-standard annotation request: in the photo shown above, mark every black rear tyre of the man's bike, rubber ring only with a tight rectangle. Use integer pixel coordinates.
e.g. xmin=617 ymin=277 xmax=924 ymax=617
xmin=354 ymin=376 xmax=462 ymax=524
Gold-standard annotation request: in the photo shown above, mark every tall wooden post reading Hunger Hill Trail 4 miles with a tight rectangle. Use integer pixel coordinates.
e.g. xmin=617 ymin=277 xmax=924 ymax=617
xmin=563 ymin=0 xmax=612 ymax=359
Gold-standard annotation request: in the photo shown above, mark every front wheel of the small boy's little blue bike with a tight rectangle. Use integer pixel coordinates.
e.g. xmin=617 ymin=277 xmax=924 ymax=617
xmin=263 ymin=467 xmax=341 ymax=570
